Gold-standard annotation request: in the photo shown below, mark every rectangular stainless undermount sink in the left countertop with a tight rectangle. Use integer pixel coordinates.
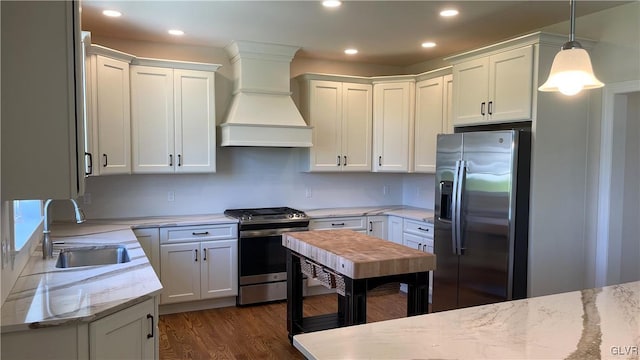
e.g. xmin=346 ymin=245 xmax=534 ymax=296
xmin=56 ymin=245 xmax=131 ymax=268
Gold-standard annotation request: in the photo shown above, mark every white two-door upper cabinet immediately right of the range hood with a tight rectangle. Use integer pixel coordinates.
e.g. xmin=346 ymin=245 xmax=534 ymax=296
xmin=299 ymin=75 xmax=373 ymax=172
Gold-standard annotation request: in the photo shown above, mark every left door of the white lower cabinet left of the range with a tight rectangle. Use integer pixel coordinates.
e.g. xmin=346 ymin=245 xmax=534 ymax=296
xmin=160 ymin=243 xmax=201 ymax=304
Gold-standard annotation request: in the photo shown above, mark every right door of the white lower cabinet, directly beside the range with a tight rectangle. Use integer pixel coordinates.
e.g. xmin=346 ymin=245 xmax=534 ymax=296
xmin=200 ymin=239 xmax=238 ymax=299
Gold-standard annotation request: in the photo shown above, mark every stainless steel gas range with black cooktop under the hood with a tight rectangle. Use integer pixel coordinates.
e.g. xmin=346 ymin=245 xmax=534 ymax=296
xmin=224 ymin=207 xmax=309 ymax=305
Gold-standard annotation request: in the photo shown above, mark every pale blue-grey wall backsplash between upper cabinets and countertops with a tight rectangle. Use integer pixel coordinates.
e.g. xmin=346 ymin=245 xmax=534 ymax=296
xmin=76 ymin=147 xmax=433 ymax=219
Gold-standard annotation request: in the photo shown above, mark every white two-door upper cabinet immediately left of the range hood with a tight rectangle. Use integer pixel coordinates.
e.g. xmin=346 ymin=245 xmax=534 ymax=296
xmin=131 ymin=65 xmax=216 ymax=173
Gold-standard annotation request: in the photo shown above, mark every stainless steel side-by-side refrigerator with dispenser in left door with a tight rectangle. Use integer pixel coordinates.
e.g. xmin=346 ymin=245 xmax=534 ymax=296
xmin=432 ymin=129 xmax=531 ymax=311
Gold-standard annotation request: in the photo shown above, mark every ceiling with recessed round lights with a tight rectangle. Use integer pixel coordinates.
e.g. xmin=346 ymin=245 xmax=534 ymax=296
xmin=82 ymin=0 xmax=629 ymax=66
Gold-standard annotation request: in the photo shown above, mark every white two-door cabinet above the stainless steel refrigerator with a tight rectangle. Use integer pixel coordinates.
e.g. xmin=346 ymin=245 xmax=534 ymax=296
xmin=453 ymin=45 xmax=533 ymax=126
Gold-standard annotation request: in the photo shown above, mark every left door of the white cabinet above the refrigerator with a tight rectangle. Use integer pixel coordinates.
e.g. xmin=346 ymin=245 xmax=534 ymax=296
xmin=453 ymin=58 xmax=489 ymax=126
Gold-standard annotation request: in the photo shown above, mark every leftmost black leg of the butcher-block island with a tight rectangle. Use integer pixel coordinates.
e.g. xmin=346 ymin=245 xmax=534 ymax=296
xmin=287 ymin=249 xmax=302 ymax=343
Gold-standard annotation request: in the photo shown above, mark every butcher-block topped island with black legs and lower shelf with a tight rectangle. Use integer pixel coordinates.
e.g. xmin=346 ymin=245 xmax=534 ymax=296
xmin=282 ymin=230 xmax=436 ymax=340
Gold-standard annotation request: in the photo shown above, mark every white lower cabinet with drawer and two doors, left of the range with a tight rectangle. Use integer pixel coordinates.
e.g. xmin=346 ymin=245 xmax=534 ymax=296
xmin=160 ymin=224 xmax=238 ymax=304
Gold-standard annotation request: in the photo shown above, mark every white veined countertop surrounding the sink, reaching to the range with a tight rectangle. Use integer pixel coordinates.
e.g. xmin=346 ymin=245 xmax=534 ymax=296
xmin=1 ymin=214 xmax=237 ymax=332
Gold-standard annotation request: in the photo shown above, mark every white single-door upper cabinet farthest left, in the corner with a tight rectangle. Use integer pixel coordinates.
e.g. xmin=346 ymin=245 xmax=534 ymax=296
xmin=85 ymin=45 xmax=133 ymax=175
